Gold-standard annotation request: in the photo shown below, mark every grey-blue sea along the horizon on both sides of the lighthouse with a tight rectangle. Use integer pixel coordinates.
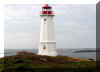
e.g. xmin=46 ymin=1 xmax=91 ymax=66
xmin=4 ymin=48 xmax=96 ymax=60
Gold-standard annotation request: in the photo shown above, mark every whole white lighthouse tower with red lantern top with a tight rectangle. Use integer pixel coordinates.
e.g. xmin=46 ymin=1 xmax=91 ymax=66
xmin=38 ymin=4 xmax=57 ymax=56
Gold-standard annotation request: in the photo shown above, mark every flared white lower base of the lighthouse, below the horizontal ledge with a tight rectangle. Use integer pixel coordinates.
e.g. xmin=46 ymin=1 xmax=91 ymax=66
xmin=38 ymin=42 xmax=57 ymax=56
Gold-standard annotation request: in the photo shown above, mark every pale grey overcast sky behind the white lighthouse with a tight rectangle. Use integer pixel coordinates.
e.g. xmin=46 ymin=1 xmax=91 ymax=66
xmin=5 ymin=4 xmax=96 ymax=49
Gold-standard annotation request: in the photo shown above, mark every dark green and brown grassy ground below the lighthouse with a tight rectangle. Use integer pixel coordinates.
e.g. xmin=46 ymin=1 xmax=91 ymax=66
xmin=0 ymin=52 xmax=97 ymax=72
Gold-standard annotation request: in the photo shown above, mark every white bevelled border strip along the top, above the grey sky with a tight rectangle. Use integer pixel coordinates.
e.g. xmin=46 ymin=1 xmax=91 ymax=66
xmin=2 ymin=0 xmax=97 ymax=4
